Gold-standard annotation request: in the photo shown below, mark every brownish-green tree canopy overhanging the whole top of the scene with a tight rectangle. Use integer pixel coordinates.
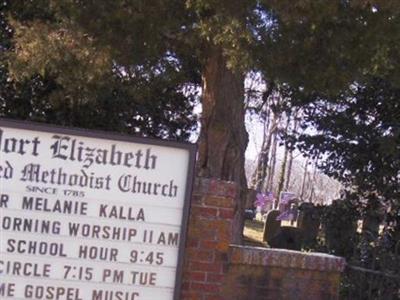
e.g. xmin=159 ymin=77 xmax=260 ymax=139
xmin=3 ymin=0 xmax=400 ymax=143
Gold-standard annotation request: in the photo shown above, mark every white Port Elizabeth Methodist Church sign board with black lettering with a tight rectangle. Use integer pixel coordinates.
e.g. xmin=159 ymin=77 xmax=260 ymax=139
xmin=0 ymin=119 xmax=195 ymax=300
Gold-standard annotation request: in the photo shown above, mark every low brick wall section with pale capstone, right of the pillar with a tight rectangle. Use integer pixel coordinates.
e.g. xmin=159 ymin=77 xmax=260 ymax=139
xmin=224 ymin=246 xmax=345 ymax=300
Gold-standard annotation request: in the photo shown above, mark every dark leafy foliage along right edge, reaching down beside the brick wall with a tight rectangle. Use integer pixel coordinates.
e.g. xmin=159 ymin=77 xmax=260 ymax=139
xmin=290 ymin=77 xmax=400 ymax=299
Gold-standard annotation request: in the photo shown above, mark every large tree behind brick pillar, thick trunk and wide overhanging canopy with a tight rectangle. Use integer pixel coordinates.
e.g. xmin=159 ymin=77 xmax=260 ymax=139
xmin=6 ymin=0 xmax=400 ymax=241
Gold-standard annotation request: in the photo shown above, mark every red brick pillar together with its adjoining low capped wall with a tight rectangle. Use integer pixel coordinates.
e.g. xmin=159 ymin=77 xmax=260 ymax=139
xmin=181 ymin=178 xmax=345 ymax=300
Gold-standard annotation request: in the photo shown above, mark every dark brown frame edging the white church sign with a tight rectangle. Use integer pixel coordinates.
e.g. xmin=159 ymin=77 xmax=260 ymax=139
xmin=0 ymin=117 xmax=197 ymax=300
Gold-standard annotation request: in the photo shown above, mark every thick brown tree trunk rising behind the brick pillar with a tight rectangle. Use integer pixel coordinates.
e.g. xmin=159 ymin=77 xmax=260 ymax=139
xmin=197 ymin=47 xmax=248 ymax=243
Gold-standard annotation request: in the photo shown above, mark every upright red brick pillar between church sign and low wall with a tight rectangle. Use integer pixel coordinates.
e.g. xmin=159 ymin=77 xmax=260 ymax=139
xmin=181 ymin=178 xmax=238 ymax=300
